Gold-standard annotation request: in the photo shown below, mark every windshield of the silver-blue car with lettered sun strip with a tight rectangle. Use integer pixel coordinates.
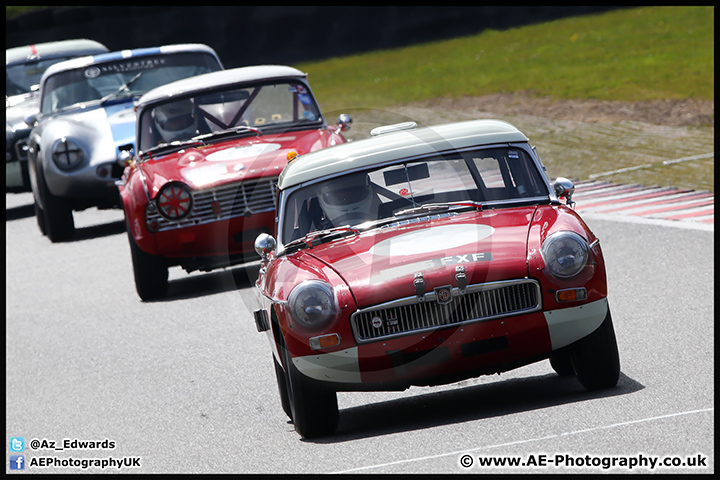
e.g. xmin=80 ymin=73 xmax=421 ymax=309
xmin=40 ymin=52 xmax=220 ymax=114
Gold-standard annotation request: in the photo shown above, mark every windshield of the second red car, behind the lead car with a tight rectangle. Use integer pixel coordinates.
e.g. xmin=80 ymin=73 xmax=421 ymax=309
xmin=138 ymin=81 xmax=322 ymax=152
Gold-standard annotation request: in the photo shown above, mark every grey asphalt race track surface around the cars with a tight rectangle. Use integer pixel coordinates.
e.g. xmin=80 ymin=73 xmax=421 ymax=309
xmin=6 ymin=189 xmax=715 ymax=474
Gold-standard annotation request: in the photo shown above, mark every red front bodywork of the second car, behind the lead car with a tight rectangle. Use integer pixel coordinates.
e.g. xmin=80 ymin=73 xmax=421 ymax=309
xmin=120 ymin=128 xmax=345 ymax=258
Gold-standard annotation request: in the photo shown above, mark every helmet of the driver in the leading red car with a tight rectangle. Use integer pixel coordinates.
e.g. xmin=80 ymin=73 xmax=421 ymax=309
xmin=318 ymin=174 xmax=375 ymax=227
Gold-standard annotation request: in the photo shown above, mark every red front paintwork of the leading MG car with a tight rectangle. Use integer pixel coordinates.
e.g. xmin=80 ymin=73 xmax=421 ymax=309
xmin=258 ymin=205 xmax=607 ymax=383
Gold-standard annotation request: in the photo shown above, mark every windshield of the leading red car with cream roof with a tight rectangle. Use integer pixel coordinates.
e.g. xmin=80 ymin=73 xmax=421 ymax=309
xmin=279 ymin=147 xmax=549 ymax=244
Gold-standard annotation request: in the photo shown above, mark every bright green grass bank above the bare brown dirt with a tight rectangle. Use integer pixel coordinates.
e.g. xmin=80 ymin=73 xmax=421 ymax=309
xmin=297 ymin=6 xmax=715 ymax=110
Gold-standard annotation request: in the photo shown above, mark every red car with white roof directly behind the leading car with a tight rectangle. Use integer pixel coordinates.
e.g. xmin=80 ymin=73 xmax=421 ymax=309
xmin=118 ymin=65 xmax=352 ymax=301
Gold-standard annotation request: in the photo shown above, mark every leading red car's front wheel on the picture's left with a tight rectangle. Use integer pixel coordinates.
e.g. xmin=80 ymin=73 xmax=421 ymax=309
xmin=280 ymin=340 xmax=339 ymax=438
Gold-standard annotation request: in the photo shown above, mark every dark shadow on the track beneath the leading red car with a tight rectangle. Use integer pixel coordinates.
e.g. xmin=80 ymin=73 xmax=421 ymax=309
xmin=304 ymin=373 xmax=645 ymax=443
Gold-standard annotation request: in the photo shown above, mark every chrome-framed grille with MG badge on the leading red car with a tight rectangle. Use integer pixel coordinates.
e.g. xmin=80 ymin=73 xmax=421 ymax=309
xmin=350 ymin=279 xmax=542 ymax=343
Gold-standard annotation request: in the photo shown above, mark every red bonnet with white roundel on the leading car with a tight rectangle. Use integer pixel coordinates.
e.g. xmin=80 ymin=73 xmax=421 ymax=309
xmin=296 ymin=206 xmax=536 ymax=308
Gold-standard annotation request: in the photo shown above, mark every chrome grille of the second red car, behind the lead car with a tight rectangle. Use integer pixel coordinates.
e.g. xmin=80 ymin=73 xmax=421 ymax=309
xmin=147 ymin=177 xmax=277 ymax=231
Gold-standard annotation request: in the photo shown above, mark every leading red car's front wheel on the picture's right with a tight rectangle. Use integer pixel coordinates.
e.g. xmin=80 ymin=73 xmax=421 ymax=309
xmin=571 ymin=310 xmax=620 ymax=390
